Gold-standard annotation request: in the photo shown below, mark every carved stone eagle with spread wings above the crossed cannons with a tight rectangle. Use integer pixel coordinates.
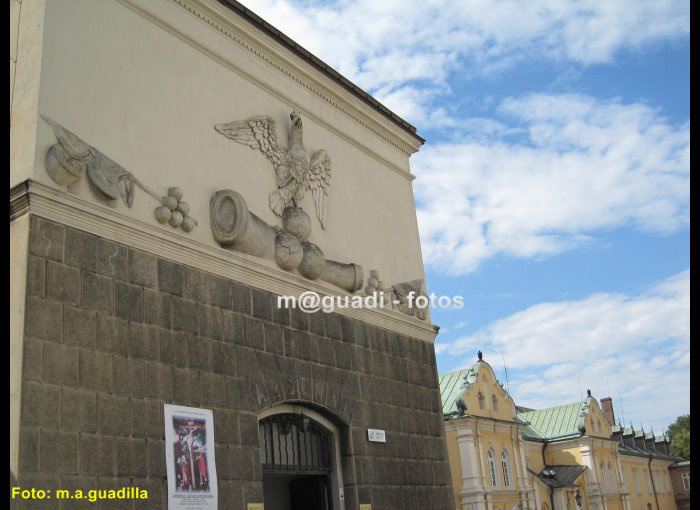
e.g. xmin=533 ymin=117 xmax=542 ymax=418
xmin=215 ymin=111 xmax=331 ymax=229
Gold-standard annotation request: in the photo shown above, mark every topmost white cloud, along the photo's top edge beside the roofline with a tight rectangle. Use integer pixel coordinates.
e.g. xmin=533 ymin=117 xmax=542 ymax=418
xmin=247 ymin=0 xmax=690 ymax=122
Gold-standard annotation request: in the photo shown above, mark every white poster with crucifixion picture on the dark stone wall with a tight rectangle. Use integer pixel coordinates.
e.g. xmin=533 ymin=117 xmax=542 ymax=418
xmin=165 ymin=404 xmax=218 ymax=510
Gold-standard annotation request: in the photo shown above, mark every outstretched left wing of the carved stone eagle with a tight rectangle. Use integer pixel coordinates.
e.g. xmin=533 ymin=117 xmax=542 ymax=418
xmin=214 ymin=116 xmax=289 ymax=186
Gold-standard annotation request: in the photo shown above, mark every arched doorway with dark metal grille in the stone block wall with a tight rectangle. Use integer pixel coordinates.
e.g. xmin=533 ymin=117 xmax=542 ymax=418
xmin=258 ymin=405 xmax=343 ymax=510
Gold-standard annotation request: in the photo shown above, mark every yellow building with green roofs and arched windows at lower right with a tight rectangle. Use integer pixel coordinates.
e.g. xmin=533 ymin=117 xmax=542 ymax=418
xmin=440 ymin=353 xmax=689 ymax=510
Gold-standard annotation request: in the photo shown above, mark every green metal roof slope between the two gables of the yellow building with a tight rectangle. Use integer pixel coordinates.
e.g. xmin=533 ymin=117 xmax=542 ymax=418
xmin=517 ymin=397 xmax=592 ymax=440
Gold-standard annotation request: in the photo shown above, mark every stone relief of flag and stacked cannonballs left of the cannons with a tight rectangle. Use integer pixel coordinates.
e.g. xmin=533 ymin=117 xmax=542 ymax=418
xmin=41 ymin=115 xmax=197 ymax=232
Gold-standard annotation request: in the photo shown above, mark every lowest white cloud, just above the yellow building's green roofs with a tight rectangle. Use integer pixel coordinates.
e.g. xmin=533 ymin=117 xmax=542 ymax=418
xmin=436 ymin=271 xmax=690 ymax=432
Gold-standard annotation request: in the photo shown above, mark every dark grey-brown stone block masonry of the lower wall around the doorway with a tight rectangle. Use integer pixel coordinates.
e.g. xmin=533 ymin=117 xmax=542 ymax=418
xmin=18 ymin=216 xmax=454 ymax=510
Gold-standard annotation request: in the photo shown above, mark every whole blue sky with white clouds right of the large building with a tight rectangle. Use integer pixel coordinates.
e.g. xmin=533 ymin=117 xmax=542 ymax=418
xmin=239 ymin=0 xmax=690 ymax=433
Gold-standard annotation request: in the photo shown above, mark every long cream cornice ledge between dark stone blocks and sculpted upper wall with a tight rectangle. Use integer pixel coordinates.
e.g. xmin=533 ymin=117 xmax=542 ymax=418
xmin=10 ymin=180 xmax=437 ymax=343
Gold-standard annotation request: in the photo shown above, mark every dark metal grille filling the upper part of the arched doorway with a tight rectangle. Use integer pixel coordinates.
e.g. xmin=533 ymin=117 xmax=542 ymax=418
xmin=258 ymin=414 xmax=332 ymax=474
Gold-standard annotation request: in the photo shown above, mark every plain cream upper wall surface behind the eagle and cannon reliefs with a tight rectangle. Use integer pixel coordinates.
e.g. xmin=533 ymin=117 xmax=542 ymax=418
xmin=20 ymin=0 xmax=424 ymax=298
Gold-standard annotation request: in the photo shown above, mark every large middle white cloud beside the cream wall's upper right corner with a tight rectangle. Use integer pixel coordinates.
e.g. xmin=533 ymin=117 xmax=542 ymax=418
xmin=412 ymin=94 xmax=690 ymax=273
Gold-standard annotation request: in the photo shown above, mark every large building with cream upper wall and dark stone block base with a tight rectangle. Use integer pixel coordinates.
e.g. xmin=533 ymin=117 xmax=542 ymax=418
xmin=10 ymin=0 xmax=456 ymax=510
